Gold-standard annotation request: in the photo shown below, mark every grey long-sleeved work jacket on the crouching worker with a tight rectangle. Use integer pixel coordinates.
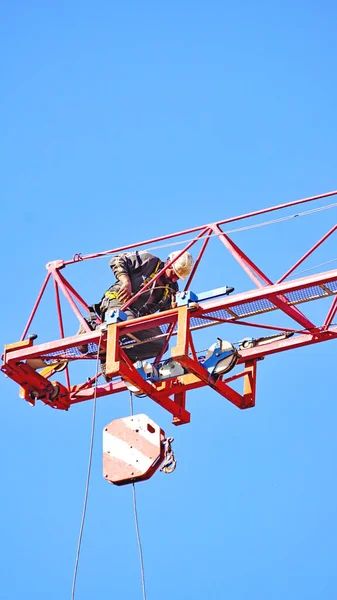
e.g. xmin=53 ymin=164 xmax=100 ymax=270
xmin=101 ymin=251 xmax=179 ymax=317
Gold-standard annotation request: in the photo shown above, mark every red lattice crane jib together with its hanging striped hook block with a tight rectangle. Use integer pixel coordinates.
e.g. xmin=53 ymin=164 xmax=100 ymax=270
xmin=1 ymin=191 xmax=337 ymax=485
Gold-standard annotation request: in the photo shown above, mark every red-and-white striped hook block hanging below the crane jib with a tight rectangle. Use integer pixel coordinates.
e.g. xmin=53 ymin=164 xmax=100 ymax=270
xmin=103 ymin=414 xmax=165 ymax=485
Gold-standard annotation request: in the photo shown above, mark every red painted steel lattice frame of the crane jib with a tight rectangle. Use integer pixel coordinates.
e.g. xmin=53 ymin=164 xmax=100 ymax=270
xmin=2 ymin=191 xmax=337 ymax=425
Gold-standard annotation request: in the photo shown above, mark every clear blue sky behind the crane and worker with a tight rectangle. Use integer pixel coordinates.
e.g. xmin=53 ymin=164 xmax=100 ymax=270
xmin=0 ymin=0 xmax=337 ymax=600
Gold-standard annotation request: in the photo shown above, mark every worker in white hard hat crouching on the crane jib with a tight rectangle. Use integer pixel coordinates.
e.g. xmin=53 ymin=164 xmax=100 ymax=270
xmin=98 ymin=251 xmax=194 ymax=375
